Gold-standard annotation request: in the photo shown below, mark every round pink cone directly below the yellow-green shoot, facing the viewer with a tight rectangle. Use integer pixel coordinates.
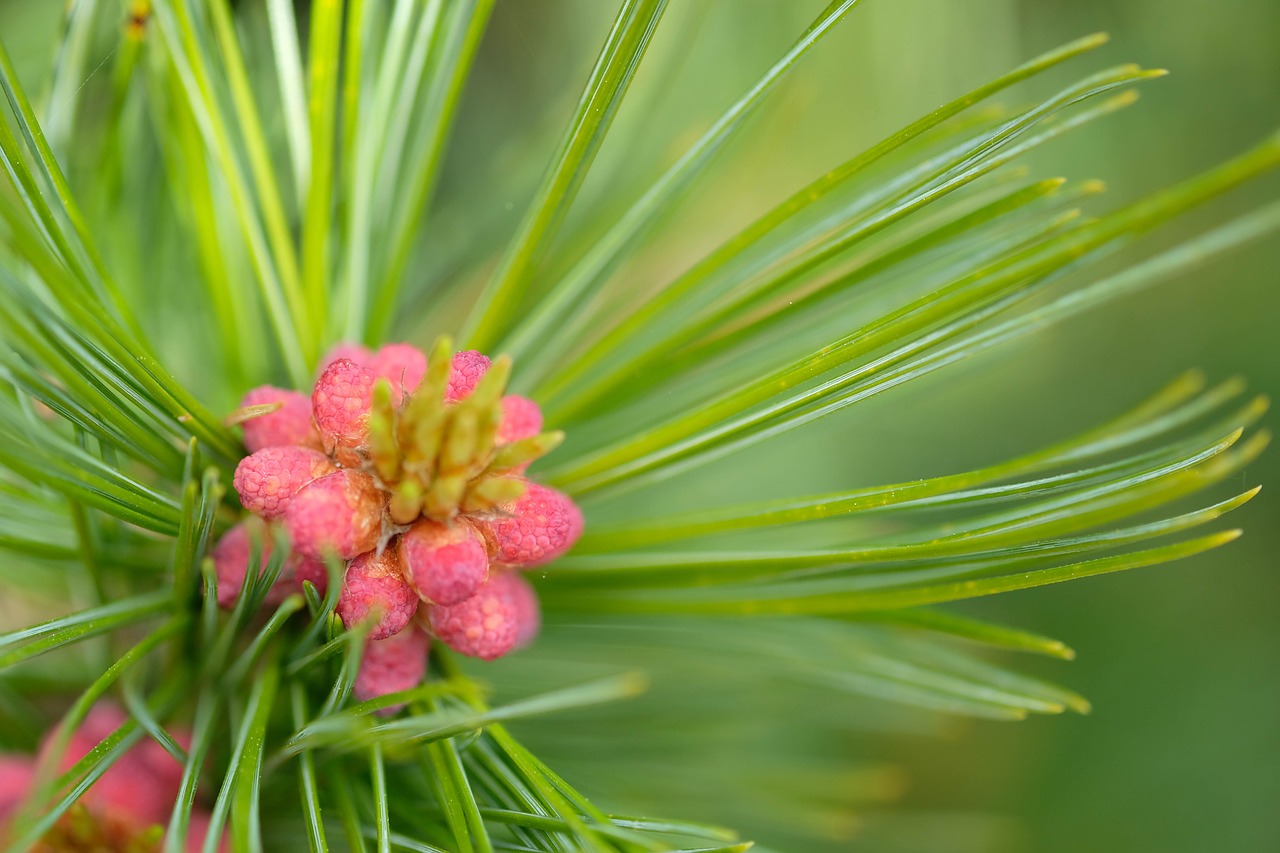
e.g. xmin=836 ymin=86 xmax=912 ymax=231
xmin=399 ymin=519 xmax=489 ymax=605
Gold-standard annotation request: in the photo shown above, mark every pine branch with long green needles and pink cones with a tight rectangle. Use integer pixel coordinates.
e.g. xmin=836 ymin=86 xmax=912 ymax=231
xmin=0 ymin=0 xmax=1280 ymax=853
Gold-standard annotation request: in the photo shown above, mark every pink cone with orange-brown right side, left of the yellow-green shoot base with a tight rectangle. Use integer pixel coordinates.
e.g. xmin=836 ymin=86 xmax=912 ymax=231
xmin=284 ymin=469 xmax=384 ymax=560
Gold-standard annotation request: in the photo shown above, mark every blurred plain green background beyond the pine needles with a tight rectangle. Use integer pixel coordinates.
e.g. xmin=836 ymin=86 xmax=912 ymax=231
xmin=0 ymin=0 xmax=1280 ymax=853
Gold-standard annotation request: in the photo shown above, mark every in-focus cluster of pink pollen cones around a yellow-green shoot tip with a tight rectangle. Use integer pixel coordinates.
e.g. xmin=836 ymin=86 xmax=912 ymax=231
xmin=212 ymin=341 xmax=582 ymax=699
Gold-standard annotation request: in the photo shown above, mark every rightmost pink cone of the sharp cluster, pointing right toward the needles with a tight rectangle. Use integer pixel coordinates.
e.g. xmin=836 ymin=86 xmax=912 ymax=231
xmin=481 ymin=483 xmax=582 ymax=569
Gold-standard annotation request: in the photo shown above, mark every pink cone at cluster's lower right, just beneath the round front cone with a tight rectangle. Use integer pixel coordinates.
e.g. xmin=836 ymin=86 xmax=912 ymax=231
xmin=426 ymin=571 xmax=538 ymax=661
